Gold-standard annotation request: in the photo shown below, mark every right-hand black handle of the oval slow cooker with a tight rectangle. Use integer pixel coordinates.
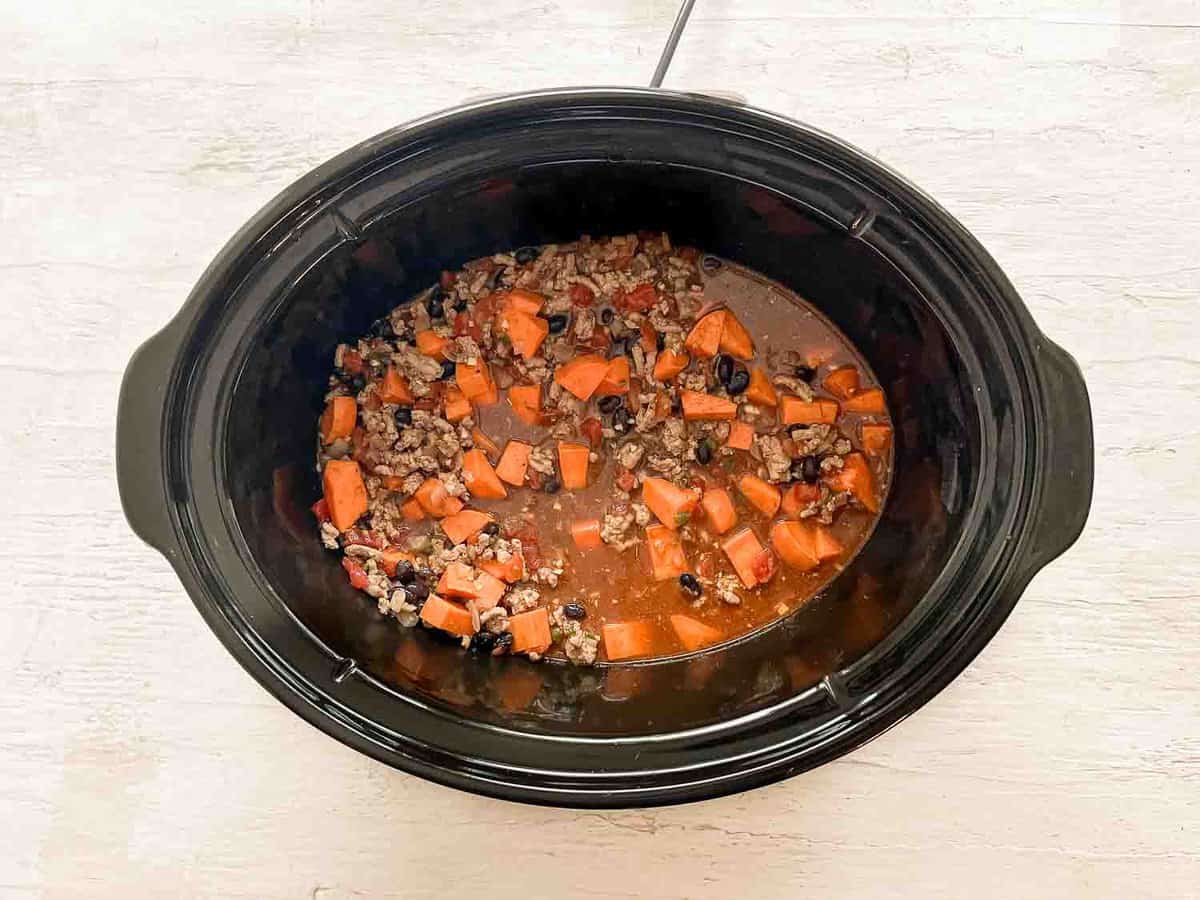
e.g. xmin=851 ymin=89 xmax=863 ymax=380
xmin=1022 ymin=341 xmax=1094 ymax=578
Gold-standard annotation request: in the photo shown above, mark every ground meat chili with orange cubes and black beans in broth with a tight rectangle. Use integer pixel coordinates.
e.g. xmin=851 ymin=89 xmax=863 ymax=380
xmin=313 ymin=233 xmax=892 ymax=665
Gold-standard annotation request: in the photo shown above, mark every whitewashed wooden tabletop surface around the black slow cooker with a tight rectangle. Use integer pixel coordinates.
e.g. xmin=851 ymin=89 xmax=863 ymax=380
xmin=0 ymin=0 xmax=1200 ymax=900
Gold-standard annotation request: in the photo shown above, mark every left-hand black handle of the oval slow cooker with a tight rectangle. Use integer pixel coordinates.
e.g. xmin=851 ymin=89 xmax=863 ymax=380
xmin=116 ymin=317 xmax=182 ymax=558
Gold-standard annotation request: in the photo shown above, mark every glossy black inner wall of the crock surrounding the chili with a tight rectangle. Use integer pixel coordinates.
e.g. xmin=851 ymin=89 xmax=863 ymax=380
xmin=217 ymin=160 xmax=979 ymax=737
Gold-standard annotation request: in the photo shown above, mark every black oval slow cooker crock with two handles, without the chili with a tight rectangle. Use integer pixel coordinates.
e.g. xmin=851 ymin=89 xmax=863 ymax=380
xmin=118 ymin=91 xmax=1091 ymax=806
